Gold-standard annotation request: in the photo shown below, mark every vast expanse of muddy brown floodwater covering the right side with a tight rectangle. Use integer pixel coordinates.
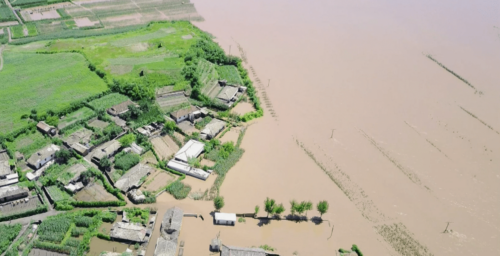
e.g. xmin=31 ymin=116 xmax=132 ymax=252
xmin=181 ymin=0 xmax=500 ymax=255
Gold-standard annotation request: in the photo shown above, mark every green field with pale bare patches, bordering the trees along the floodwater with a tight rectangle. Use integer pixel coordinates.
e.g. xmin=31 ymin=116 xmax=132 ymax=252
xmin=10 ymin=22 xmax=203 ymax=87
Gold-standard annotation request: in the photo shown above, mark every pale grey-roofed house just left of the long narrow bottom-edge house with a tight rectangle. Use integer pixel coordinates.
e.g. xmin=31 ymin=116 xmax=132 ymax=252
xmin=109 ymin=222 xmax=149 ymax=244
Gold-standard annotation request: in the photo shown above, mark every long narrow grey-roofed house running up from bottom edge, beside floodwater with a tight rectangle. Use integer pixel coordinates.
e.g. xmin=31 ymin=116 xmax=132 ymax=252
xmin=154 ymin=207 xmax=184 ymax=256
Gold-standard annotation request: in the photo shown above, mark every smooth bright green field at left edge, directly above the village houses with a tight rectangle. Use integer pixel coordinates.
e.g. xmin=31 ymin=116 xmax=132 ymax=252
xmin=0 ymin=48 xmax=108 ymax=134
